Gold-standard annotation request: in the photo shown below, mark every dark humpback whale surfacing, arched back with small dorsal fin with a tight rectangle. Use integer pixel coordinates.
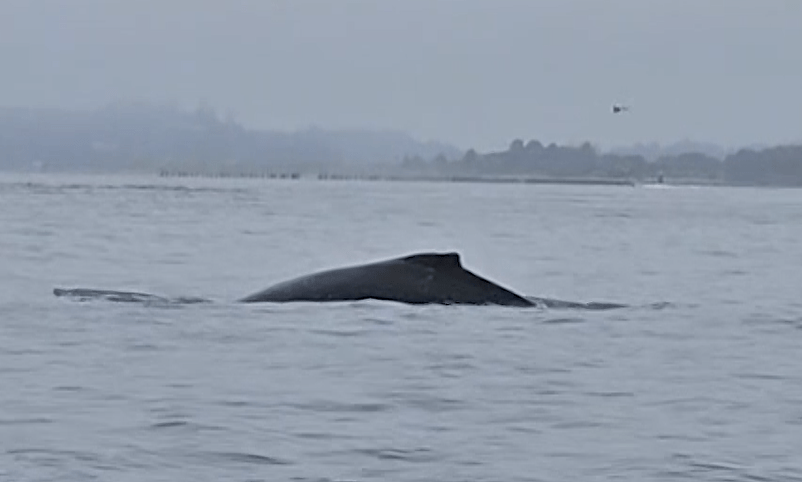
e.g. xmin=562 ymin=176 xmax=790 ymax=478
xmin=53 ymin=252 xmax=624 ymax=309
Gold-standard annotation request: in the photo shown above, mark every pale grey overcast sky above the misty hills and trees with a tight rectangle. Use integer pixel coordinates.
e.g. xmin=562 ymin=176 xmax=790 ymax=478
xmin=0 ymin=0 xmax=802 ymax=151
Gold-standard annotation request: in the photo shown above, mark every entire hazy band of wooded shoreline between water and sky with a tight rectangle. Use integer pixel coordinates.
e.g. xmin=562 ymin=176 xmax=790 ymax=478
xmin=0 ymin=103 xmax=802 ymax=187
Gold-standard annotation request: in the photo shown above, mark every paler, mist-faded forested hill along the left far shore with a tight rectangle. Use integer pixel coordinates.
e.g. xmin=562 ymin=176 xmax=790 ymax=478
xmin=0 ymin=104 xmax=463 ymax=171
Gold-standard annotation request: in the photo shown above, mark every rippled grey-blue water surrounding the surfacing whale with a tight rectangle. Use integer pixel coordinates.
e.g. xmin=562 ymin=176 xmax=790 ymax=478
xmin=0 ymin=174 xmax=802 ymax=482
